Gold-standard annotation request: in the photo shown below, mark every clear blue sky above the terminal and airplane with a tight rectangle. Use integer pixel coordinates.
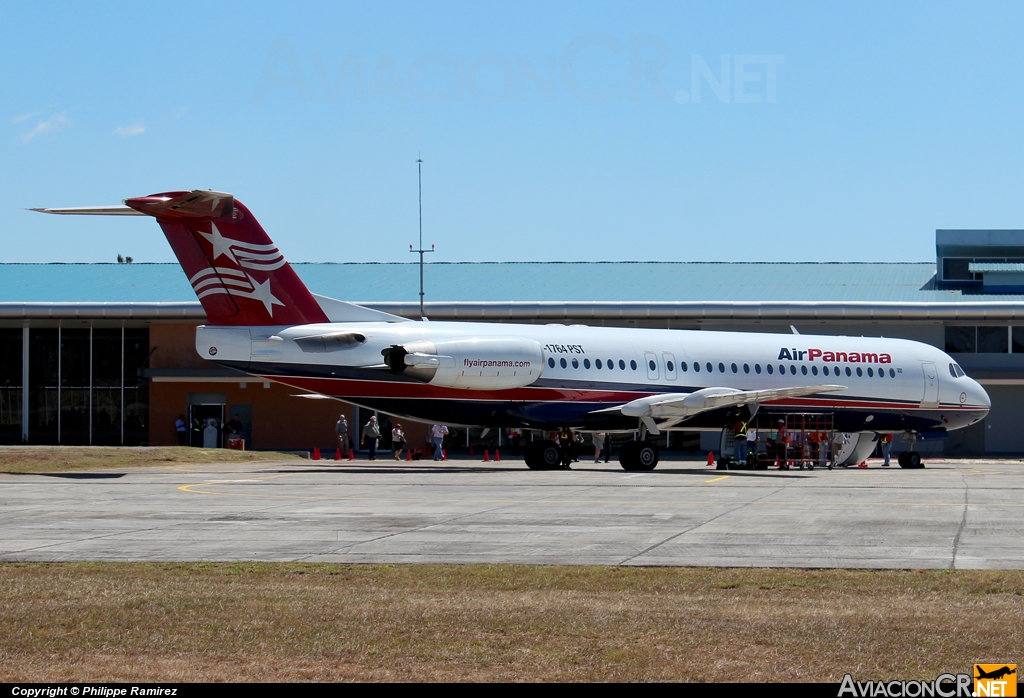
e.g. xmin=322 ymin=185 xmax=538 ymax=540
xmin=0 ymin=2 xmax=1024 ymax=262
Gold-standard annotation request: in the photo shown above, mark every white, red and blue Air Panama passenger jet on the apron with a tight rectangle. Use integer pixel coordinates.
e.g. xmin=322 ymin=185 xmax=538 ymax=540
xmin=32 ymin=189 xmax=991 ymax=471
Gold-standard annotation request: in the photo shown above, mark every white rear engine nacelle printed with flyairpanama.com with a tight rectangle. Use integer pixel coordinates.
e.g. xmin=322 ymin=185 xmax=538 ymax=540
xmin=381 ymin=337 xmax=544 ymax=390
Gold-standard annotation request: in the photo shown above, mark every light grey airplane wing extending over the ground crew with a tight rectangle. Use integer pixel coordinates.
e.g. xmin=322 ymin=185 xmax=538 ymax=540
xmin=597 ymin=385 xmax=847 ymax=434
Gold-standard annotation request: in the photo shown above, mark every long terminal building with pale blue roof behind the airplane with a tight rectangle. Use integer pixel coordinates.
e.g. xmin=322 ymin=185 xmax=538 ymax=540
xmin=0 ymin=230 xmax=1024 ymax=457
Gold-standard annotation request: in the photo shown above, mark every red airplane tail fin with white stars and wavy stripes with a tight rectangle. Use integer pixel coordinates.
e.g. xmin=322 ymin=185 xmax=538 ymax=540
xmin=125 ymin=190 xmax=328 ymax=325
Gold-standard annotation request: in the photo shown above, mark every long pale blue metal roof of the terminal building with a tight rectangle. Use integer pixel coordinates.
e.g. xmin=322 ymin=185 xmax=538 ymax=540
xmin=0 ymin=262 xmax=1007 ymax=303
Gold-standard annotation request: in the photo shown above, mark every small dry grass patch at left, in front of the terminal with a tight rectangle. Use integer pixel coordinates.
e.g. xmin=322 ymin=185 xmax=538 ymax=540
xmin=0 ymin=446 xmax=298 ymax=473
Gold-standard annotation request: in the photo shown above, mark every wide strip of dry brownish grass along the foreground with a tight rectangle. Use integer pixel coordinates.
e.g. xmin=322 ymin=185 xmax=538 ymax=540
xmin=0 ymin=563 xmax=1024 ymax=682
